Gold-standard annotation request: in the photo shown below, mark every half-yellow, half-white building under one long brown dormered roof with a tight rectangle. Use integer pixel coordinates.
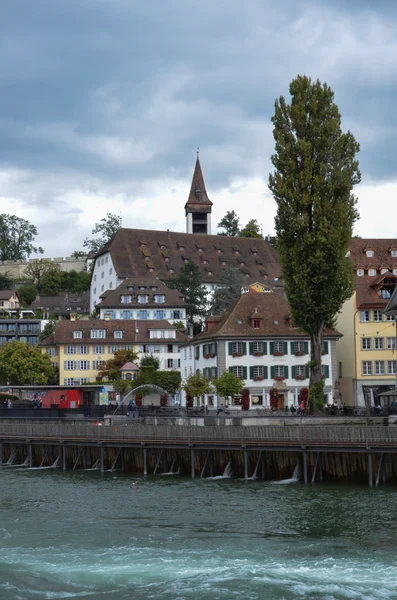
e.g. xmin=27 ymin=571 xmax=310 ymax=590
xmin=39 ymin=319 xmax=185 ymax=385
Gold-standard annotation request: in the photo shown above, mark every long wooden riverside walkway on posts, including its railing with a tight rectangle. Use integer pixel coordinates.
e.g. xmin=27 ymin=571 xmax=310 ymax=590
xmin=0 ymin=419 xmax=397 ymax=487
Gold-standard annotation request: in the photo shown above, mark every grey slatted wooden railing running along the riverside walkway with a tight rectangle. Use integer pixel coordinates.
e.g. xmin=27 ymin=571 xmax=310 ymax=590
xmin=0 ymin=421 xmax=397 ymax=448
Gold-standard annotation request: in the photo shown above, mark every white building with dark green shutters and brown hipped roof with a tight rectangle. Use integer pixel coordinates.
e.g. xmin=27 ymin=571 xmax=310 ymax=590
xmin=181 ymin=285 xmax=340 ymax=409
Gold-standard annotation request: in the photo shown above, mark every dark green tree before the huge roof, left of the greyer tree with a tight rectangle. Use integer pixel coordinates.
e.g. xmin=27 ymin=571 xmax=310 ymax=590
xmin=166 ymin=260 xmax=207 ymax=324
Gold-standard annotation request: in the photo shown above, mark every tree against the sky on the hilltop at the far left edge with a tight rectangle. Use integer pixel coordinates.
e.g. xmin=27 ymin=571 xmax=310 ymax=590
xmin=0 ymin=213 xmax=44 ymax=260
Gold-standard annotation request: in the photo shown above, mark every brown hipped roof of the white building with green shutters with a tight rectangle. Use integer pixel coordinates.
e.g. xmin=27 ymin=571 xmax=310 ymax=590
xmin=194 ymin=292 xmax=340 ymax=341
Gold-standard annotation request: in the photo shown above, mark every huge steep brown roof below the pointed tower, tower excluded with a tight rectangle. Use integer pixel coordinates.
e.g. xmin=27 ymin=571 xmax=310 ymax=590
xmin=96 ymin=229 xmax=281 ymax=285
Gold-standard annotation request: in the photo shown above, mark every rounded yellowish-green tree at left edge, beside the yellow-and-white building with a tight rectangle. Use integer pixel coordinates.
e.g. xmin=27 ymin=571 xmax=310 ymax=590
xmin=0 ymin=341 xmax=54 ymax=385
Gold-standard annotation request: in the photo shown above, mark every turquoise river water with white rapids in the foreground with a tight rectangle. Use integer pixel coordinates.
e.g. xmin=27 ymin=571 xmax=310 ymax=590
xmin=0 ymin=469 xmax=397 ymax=600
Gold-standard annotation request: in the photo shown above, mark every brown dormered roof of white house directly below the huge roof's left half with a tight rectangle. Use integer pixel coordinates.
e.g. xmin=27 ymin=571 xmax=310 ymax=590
xmin=96 ymin=277 xmax=185 ymax=309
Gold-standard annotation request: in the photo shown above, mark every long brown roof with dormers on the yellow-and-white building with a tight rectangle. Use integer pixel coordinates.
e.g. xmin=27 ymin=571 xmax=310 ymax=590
xmin=39 ymin=319 xmax=185 ymax=346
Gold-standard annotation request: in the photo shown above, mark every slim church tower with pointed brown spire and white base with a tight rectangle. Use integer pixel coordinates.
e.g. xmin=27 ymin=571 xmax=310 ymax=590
xmin=185 ymin=152 xmax=212 ymax=234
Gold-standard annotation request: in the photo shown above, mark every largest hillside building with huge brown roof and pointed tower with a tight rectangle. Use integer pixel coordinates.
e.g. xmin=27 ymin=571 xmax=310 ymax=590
xmin=90 ymin=160 xmax=282 ymax=311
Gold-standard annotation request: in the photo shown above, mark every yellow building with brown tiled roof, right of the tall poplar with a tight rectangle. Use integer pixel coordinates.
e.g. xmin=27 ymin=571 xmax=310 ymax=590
xmin=337 ymin=239 xmax=397 ymax=406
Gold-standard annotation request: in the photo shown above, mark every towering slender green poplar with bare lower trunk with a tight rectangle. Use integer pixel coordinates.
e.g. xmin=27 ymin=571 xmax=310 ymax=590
xmin=269 ymin=76 xmax=361 ymax=404
